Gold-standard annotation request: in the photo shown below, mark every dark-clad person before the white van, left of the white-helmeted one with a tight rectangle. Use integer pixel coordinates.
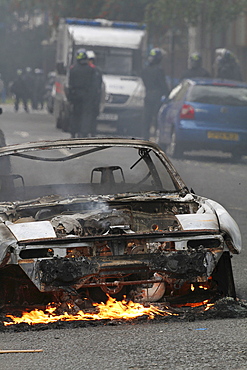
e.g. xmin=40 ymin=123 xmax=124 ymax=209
xmin=68 ymin=49 xmax=96 ymax=137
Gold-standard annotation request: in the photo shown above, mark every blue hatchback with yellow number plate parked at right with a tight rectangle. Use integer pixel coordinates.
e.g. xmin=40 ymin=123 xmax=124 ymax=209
xmin=156 ymin=78 xmax=247 ymax=160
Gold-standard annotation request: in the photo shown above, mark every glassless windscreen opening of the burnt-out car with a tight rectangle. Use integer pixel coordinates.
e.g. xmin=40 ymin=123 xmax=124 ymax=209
xmin=0 ymin=146 xmax=177 ymax=201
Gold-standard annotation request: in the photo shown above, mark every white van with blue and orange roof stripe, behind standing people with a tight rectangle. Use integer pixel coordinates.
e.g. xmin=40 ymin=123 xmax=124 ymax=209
xmin=54 ymin=18 xmax=147 ymax=134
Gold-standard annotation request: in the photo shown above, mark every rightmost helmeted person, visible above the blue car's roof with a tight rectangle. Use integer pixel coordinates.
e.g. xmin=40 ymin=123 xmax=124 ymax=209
xmin=215 ymin=48 xmax=243 ymax=81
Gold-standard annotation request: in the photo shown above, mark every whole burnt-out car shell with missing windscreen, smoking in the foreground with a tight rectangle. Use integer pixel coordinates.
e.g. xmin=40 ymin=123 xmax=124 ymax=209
xmin=0 ymin=138 xmax=241 ymax=307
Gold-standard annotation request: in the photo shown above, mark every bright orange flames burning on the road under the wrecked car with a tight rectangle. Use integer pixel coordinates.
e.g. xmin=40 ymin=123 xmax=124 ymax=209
xmin=3 ymin=296 xmax=174 ymax=326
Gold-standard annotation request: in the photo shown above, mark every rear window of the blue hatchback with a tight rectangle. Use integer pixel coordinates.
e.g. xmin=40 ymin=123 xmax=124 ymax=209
xmin=186 ymin=85 xmax=247 ymax=106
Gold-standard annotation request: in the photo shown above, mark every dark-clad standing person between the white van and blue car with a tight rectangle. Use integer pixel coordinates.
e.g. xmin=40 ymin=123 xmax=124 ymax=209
xmin=142 ymin=48 xmax=169 ymax=140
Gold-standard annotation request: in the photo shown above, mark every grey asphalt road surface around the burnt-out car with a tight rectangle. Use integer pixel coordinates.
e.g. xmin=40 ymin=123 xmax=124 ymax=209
xmin=0 ymin=106 xmax=247 ymax=370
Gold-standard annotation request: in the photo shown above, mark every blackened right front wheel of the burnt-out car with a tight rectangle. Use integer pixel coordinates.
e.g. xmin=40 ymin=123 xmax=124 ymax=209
xmin=212 ymin=252 xmax=236 ymax=299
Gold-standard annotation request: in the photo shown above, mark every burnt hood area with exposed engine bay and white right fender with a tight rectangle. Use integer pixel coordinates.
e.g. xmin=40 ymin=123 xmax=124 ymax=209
xmin=0 ymin=193 xmax=241 ymax=261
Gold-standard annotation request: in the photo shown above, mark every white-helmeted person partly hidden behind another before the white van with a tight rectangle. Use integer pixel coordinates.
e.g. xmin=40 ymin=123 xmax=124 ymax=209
xmin=87 ymin=50 xmax=103 ymax=136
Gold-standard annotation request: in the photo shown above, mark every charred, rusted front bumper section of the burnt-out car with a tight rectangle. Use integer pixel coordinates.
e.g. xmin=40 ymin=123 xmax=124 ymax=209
xmin=12 ymin=231 xmax=224 ymax=294
